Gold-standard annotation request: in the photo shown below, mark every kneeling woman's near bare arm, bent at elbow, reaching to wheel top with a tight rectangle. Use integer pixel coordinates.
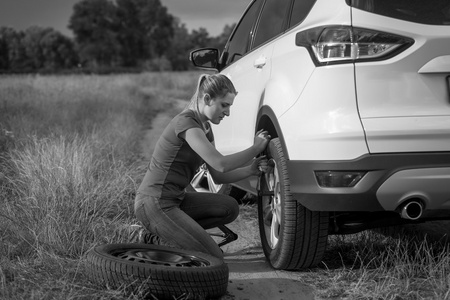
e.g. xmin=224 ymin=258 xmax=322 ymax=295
xmin=181 ymin=128 xmax=269 ymax=173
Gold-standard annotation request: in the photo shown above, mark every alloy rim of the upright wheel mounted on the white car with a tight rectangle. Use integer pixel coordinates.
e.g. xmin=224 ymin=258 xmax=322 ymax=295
xmin=264 ymin=159 xmax=281 ymax=249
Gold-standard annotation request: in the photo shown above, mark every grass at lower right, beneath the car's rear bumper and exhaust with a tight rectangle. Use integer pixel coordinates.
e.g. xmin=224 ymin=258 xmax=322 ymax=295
xmin=317 ymin=231 xmax=450 ymax=300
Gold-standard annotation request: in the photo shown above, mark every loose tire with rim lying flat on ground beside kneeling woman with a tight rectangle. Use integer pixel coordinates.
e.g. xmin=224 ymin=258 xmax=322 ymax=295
xmin=87 ymin=244 xmax=228 ymax=299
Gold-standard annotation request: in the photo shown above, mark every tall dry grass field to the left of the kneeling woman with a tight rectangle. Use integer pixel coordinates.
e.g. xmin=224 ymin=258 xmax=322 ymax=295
xmin=0 ymin=73 xmax=197 ymax=299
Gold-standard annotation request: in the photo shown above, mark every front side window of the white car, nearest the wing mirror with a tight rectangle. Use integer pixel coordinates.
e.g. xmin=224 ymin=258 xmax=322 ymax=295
xmin=225 ymin=0 xmax=263 ymax=65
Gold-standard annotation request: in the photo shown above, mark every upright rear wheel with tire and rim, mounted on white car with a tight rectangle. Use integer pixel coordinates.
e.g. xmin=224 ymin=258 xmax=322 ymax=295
xmin=258 ymin=138 xmax=329 ymax=270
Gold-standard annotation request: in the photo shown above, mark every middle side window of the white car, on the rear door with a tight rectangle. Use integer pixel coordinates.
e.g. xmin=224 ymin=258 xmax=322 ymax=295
xmin=253 ymin=0 xmax=291 ymax=48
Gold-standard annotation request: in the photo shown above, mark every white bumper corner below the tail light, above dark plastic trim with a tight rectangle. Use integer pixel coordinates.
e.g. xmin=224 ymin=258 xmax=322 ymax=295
xmin=278 ymin=65 xmax=367 ymax=160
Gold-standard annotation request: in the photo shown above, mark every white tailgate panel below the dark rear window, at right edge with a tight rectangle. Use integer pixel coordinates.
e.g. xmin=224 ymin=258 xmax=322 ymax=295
xmin=352 ymin=9 xmax=450 ymax=153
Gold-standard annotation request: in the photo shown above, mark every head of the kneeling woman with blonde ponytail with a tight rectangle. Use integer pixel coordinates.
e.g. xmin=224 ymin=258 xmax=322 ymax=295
xmin=189 ymin=74 xmax=237 ymax=124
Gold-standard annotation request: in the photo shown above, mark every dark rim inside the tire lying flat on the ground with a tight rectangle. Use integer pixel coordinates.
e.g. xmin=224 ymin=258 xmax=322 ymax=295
xmin=112 ymin=248 xmax=210 ymax=268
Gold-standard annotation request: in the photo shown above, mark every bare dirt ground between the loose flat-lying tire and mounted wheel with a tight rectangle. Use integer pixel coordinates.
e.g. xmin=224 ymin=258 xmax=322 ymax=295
xmin=215 ymin=214 xmax=314 ymax=300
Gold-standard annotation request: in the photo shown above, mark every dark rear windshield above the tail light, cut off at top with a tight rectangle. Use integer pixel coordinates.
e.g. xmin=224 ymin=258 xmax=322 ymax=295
xmin=347 ymin=0 xmax=450 ymax=25
